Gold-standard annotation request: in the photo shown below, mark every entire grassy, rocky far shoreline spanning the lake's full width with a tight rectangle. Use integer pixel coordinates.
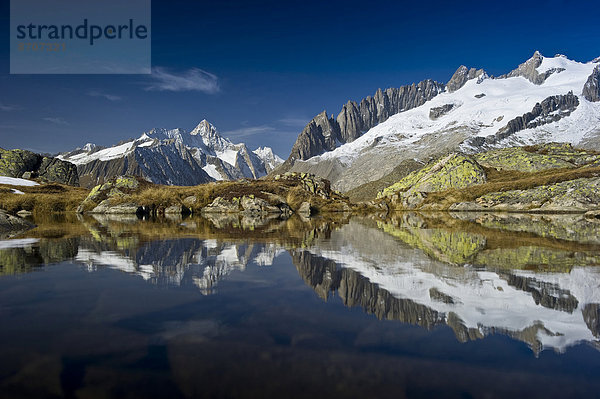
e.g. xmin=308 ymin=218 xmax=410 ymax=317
xmin=0 ymin=143 xmax=600 ymax=241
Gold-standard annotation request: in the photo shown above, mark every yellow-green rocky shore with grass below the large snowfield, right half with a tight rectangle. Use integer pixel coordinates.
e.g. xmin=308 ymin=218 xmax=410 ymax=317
xmin=371 ymin=143 xmax=600 ymax=216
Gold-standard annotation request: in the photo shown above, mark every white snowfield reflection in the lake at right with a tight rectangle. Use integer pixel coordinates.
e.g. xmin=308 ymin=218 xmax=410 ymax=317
xmin=309 ymin=220 xmax=600 ymax=351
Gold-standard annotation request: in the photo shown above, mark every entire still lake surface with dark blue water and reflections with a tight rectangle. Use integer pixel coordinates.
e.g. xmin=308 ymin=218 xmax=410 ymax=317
xmin=0 ymin=213 xmax=600 ymax=398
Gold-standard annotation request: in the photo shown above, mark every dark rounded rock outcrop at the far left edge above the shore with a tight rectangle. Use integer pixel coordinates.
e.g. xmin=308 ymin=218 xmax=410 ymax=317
xmin=0 ymin=148 xmax=79 ymax=186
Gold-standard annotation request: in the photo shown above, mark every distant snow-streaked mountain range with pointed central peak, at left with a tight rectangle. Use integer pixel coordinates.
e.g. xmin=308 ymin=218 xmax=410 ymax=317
xmin=58 ymin=120 xmax=283 ymax=187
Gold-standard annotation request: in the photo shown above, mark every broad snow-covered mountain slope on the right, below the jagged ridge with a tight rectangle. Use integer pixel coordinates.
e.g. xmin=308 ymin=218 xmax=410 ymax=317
xmin=288 ymin=52 xmax=600 ymax=191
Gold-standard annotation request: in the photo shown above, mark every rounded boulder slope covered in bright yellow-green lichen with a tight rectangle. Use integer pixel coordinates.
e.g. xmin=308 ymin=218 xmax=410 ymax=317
xmin=378 ymin=153 xmax=487 ymax=208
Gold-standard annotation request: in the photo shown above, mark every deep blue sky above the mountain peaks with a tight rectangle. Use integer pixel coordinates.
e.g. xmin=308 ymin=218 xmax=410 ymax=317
xmin=0 ymin=0 xmax=600 ymax=157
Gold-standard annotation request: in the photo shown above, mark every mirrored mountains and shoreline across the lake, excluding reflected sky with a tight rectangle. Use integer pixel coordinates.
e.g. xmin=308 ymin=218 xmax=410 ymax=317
xmin=0 ymin=213 xmax=600 ymax=353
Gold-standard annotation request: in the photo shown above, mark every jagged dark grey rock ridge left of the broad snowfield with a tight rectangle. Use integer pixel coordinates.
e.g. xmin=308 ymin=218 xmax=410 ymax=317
xmin=288 ymin=80 xmax=444 ymax=162
